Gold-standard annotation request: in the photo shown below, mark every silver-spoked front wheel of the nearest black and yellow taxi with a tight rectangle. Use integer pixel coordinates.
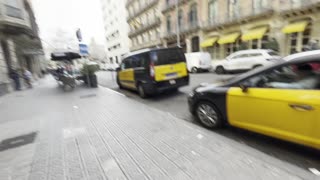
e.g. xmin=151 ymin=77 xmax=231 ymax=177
xmin=195 ymin=101 xmax=222 ymax=129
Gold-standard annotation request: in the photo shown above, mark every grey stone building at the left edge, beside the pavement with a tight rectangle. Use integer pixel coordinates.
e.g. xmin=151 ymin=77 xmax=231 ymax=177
xmin=0 ymin=0 xmax=45 ymax=95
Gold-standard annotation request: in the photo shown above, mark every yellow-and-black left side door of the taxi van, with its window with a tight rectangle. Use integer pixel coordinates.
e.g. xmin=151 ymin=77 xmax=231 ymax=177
xmin=119 ymin=58 xmax=136 ymax=89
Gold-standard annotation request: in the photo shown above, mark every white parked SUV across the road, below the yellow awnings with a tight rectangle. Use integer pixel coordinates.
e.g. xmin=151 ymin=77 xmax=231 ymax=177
xmin=212 ymin=49 xmax=281 ymax=74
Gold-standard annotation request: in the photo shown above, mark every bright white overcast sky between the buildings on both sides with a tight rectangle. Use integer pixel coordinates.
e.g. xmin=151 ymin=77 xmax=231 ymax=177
xmin=32 ymin=0 xmax=105 ymax=46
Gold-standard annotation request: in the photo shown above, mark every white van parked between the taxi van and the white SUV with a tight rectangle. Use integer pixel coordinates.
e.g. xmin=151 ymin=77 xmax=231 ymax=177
xmin=185 ymin=52 xmax=212 ymax=73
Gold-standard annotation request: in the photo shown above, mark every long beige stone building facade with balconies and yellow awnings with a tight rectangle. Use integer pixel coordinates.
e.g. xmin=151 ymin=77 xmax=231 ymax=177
xmin=126 ymin=0 xmax=320 ymax=60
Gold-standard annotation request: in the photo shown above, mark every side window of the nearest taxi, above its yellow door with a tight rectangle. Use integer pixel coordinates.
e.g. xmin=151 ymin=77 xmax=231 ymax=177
xmin=245 ymin=62 xmax=320 ymax=89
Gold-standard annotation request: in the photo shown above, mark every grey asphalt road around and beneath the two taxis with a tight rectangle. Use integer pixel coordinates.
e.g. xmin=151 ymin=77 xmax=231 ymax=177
xmin=98 ymin=72 xmax=320 ymax=174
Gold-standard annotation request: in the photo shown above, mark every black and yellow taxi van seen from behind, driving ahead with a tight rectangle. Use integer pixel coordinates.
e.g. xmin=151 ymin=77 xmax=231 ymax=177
xmin=117 ymin=48 xmax=189 ymax=98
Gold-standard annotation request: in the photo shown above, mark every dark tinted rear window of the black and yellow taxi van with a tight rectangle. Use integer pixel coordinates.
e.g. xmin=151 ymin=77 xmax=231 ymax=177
xmin=151 ymin=49 xmax=185 ymax=65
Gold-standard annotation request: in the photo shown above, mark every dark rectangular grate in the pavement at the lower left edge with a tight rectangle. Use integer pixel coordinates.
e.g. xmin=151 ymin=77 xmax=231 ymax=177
xmin=0 ymin=132 xmax=38 ymax=152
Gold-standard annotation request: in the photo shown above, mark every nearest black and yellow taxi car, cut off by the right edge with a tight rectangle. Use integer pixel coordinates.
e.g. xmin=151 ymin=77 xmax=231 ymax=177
xmin=188 ymin=51 xmax=320 ymax=149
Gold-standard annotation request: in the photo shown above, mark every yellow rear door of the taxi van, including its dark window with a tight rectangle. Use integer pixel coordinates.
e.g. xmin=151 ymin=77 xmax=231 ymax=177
xmin=151 ymin=49 xmax=188 ymax=81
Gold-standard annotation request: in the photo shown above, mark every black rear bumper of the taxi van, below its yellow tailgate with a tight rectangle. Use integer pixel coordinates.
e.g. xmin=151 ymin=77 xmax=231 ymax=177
xmin=145 ymin=76 xmax=189 ymax=94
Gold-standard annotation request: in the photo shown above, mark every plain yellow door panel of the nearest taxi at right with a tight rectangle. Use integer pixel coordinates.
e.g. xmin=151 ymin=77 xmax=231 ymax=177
xmin=227 ymin=62 xmax=320 ymax=149
